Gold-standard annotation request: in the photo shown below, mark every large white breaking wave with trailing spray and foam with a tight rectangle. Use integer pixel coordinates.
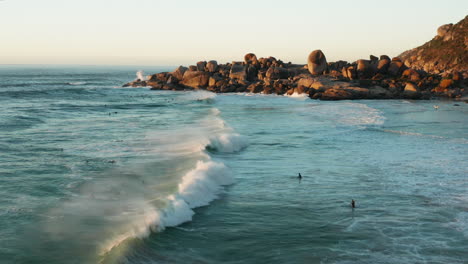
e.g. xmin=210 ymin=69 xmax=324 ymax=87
xmin=38 ymin=105 xmax=248 ymax=262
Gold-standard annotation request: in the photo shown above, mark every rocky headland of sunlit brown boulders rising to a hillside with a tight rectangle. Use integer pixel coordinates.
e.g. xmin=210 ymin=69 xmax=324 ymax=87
xmin=124 ymin=18 xmax=468 ymax=101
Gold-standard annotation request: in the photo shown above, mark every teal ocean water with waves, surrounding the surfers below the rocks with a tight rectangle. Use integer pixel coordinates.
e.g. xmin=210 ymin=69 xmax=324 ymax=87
xmin=0 ymin=66 xmax=468 ymax=263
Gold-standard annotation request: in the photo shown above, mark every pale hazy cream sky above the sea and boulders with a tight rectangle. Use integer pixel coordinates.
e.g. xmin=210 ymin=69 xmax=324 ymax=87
xmin=0 ymin=0 xmax=468 ymax=65
